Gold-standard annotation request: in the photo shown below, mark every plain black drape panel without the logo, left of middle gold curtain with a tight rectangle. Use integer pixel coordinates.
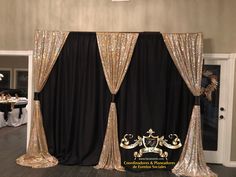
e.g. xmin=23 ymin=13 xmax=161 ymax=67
xmin=40 ymin=32 xmax=110 ymax=165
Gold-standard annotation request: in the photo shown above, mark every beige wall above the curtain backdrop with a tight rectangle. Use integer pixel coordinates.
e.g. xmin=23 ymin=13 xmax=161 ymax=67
xmin=0 ymin=0 xmax=236 ymax=161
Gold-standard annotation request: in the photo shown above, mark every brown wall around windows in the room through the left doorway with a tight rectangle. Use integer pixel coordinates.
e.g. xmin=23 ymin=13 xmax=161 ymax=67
xmin=0 ymin=55 xmax=28 ymax=88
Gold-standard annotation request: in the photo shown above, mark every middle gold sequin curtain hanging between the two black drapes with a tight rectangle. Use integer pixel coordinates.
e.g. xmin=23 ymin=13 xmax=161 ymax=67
xmin=95 ymin=33 xmax=138 ymax=171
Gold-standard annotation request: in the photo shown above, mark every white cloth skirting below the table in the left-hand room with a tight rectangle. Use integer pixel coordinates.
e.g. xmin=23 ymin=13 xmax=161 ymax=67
xmin=0 ymin=108 xmax=27 ymax=128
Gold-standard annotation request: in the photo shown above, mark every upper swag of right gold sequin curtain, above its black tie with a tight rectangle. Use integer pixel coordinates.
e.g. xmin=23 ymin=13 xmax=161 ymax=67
xmin=163 ymin=33 xmax=203 ymax=96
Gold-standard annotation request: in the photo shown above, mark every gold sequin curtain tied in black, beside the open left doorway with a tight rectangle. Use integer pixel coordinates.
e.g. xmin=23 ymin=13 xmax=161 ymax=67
xmin=16 ymin=31 xmax=68 ymax=168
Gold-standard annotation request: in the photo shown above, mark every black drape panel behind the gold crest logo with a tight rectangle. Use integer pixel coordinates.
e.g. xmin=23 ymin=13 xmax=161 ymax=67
xmin=117 ymin=32 xmax=194 ymax=170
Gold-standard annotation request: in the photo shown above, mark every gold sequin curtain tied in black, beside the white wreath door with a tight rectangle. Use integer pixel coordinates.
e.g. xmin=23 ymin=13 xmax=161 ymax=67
xmin=163 ymin=33 xmax=217 ymax=177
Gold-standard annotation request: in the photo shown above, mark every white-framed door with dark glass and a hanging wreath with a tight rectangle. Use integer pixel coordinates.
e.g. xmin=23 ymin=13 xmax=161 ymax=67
xmin=201 ymin=54 xmax=234 ymax=166
